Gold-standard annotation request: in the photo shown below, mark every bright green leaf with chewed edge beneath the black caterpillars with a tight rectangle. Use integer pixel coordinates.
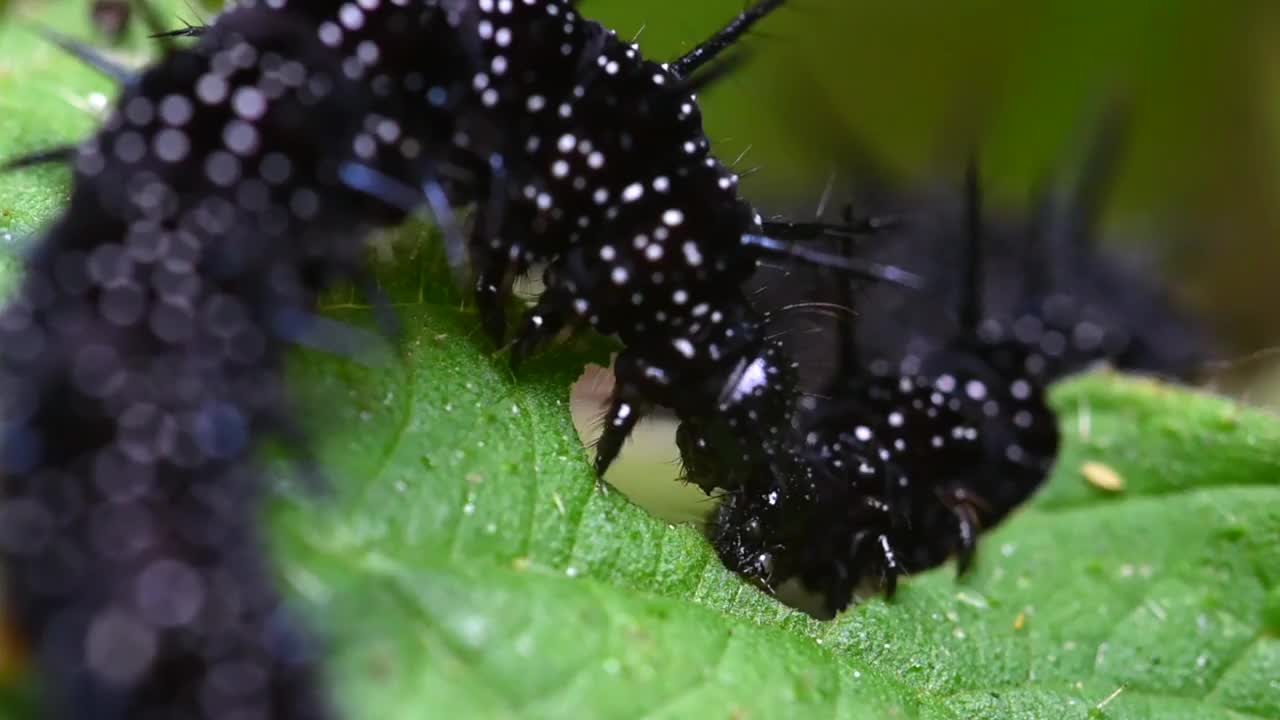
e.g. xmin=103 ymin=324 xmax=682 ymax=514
xmin=0 ymin=4 xmax=1280 ymax=720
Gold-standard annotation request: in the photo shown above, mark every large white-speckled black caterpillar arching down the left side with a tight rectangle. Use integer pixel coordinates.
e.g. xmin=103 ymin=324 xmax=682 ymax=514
xmin=0 ymin=0 xmax=908 ymax=719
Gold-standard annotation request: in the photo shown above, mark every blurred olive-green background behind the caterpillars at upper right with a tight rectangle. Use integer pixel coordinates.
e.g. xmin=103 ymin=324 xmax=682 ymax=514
xmin=584 ymin=0 xmax=1280 ymax=358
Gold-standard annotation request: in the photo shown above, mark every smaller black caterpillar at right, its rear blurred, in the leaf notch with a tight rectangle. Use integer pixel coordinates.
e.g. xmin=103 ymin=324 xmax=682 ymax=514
xmin=681 ymin=113 xmax=1208 ymax=614
